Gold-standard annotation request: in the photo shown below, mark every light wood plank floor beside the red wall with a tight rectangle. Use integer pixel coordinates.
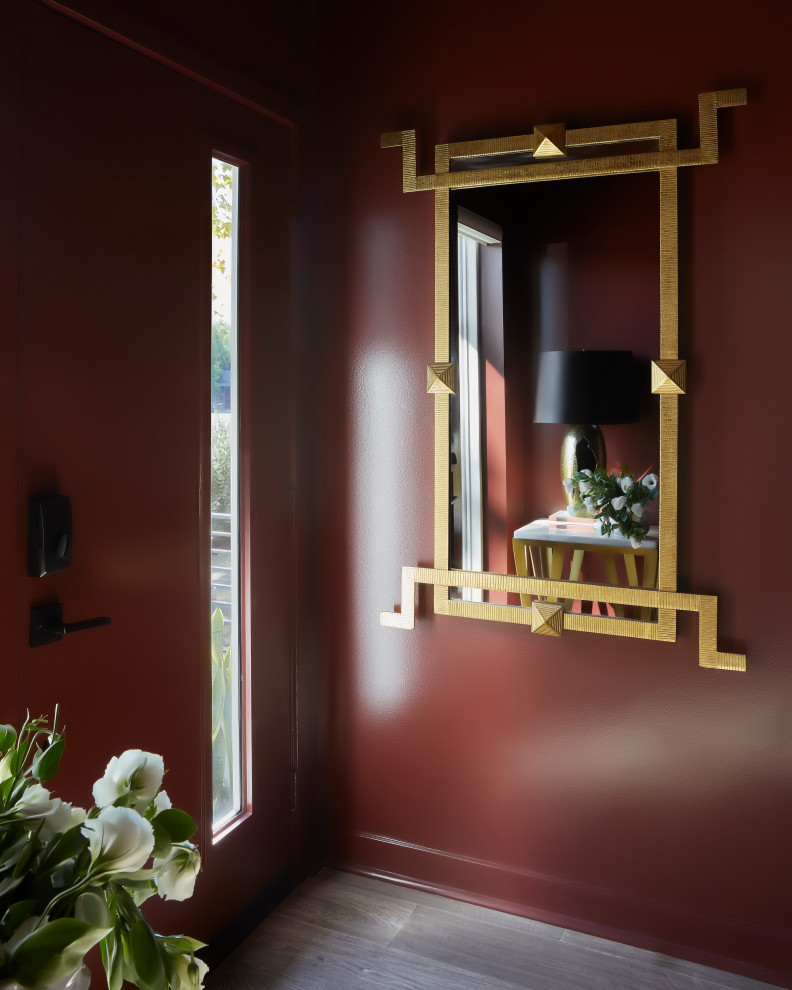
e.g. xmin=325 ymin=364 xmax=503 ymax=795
xmin=206 ymin=870 xmax=784 ymax=990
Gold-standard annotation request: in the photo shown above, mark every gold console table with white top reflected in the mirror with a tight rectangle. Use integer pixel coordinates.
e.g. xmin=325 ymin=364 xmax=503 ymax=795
xmin=513 ymin=512 xmax=658 ymax=619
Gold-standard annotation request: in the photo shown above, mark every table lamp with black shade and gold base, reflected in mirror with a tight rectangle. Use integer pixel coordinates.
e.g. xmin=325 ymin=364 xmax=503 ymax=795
xmin=534 ymin=351 xmax=639 ymax=515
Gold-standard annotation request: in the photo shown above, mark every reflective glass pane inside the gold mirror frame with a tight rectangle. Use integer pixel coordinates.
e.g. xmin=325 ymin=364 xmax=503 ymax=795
xmin=449 ymin=172 xmax=660 ymax=618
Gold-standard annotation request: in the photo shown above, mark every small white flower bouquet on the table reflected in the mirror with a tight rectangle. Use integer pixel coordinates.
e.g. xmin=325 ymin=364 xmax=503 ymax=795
xmin=564 ymin=469 xmax=659 ymax=548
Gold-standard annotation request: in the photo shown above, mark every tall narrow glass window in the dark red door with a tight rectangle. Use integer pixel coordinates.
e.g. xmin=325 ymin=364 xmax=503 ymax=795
xmin=210 ymin=158 xmax=245 ymax=832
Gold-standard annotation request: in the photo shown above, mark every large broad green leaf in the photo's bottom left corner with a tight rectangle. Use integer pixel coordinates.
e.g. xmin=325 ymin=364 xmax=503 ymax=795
xmin=8 ymin=918 xmax=111 ymax=990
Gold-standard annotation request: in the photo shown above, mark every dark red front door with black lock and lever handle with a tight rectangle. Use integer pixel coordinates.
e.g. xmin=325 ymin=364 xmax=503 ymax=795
xmin=10 ymin=4 xmax=292 ymax=937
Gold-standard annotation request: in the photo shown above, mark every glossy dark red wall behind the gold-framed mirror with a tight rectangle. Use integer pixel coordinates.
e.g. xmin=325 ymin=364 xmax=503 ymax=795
xmin=315 ymin=0 xmax=792 ymax=985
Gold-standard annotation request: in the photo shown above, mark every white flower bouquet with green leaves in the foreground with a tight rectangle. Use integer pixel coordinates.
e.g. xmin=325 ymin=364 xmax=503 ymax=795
xmin=0 ymin=709 xmax=207 ymax=990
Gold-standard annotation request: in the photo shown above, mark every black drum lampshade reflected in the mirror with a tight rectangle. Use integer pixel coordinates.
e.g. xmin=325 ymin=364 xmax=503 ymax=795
xmin=534 ymin=351 xmax=639 ymax=425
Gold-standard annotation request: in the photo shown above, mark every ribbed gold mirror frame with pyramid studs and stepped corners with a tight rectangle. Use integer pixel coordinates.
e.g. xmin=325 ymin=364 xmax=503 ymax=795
xmin=380 ymin=89 xmax=747 ymax=670
